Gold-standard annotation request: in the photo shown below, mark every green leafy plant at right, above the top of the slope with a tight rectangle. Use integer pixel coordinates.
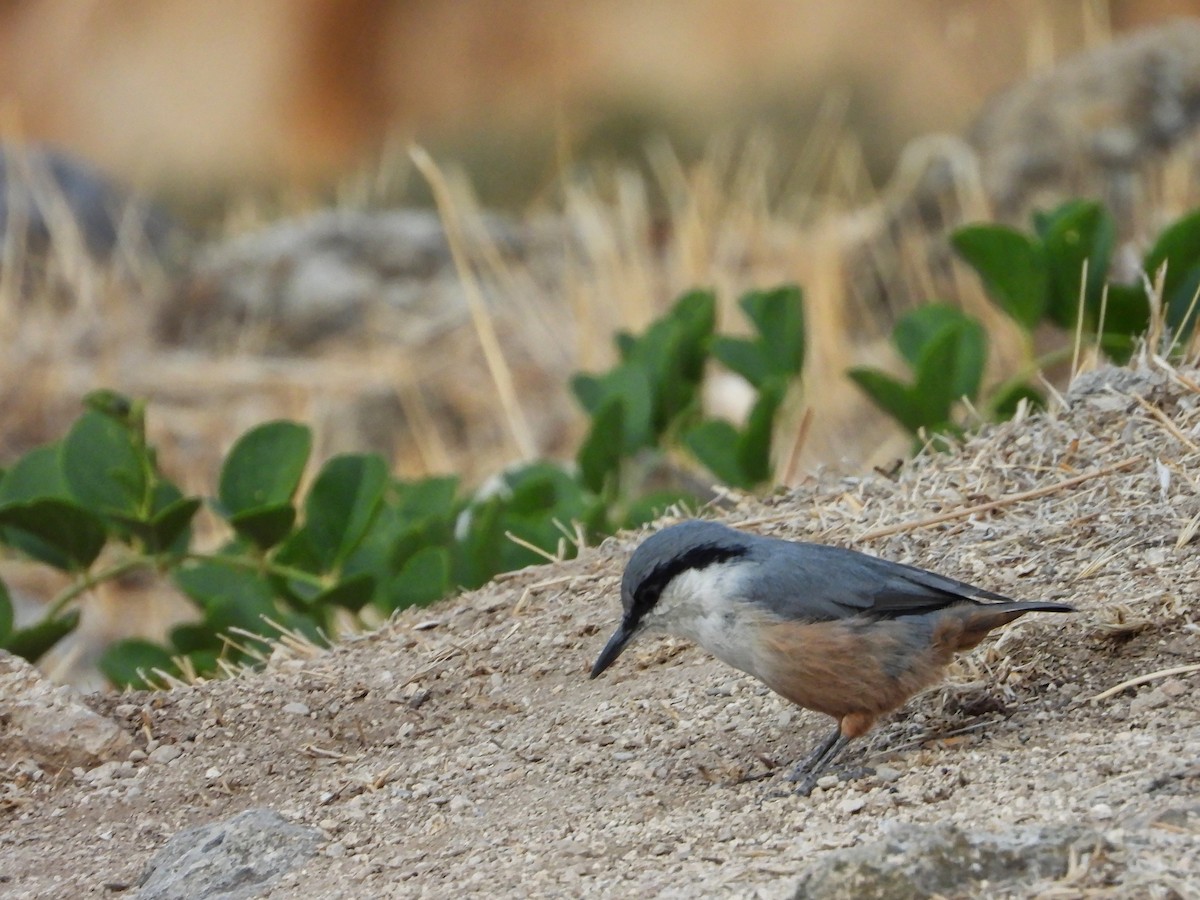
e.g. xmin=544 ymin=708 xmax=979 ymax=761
xmin=848 ymin=200 xmax=1200 ymax=434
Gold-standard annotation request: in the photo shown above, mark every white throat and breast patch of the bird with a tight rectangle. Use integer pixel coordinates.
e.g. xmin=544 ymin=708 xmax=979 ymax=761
xmin=642 ymin=562 xmax=761 ymax=674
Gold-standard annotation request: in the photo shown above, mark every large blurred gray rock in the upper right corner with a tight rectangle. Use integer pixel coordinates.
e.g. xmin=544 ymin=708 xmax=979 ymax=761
xmin=845 ymin=19 xmax=1200 ymax=312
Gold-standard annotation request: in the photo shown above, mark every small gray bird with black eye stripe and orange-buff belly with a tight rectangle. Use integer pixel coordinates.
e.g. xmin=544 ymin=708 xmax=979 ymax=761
xmin=592 ymin=520 xmax=1074 ymax=794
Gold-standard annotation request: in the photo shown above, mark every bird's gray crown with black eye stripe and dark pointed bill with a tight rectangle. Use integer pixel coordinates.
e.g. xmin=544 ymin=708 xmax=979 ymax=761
xmin=592 ymin=520 xmax=752 ymax=678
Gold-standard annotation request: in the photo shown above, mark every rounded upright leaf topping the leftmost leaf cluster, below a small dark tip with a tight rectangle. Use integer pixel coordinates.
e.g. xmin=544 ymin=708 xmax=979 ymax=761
xmin=61 ymin=410 xmax=149 ymax=518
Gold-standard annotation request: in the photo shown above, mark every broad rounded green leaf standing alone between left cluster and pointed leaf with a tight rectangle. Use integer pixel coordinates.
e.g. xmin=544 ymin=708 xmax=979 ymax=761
xmin=217 ymin=421 xmax=312 ymax=517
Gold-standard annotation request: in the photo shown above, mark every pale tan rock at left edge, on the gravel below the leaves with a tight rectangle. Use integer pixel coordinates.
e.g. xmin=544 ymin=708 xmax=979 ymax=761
xmin=0 ymin=650 xmax=133 ymax=770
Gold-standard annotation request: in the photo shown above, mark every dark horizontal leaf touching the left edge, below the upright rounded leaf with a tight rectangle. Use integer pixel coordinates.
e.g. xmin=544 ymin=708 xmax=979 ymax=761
xmin=0 ymin=497 xmax=108 ymax=571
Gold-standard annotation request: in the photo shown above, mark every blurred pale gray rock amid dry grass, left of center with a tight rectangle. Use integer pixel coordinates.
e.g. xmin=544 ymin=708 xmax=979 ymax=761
xmin=160 ymin=210 xmax=549 ymax=353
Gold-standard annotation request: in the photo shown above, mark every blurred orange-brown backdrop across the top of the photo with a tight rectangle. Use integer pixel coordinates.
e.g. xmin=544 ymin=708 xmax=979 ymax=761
xmin=0 ymin=0 xmax=1200 ymax=217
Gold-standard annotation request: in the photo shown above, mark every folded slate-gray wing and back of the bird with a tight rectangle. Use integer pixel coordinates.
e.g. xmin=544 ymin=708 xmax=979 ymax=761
xmin=740 ymin=539 xmax=1009 ymax=622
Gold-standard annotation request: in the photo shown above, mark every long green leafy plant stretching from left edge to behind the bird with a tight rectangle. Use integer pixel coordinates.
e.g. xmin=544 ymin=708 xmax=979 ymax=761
xmin=0 ymin=288 xmax=803 ymax=686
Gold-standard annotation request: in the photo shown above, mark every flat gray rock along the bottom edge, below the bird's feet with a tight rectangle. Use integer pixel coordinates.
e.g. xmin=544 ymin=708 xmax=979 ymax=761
xmin=793 ymin=824 xmax=1100 ymax=900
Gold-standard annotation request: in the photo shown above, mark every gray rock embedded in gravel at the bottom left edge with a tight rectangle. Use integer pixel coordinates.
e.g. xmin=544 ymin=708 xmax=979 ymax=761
xmin=138 ymin=809 xmax=322 ymax=900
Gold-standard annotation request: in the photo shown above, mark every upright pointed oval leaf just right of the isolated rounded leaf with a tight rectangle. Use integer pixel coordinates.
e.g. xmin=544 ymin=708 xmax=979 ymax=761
xmin=304 ymin=454 xmax=388 ymax=571
